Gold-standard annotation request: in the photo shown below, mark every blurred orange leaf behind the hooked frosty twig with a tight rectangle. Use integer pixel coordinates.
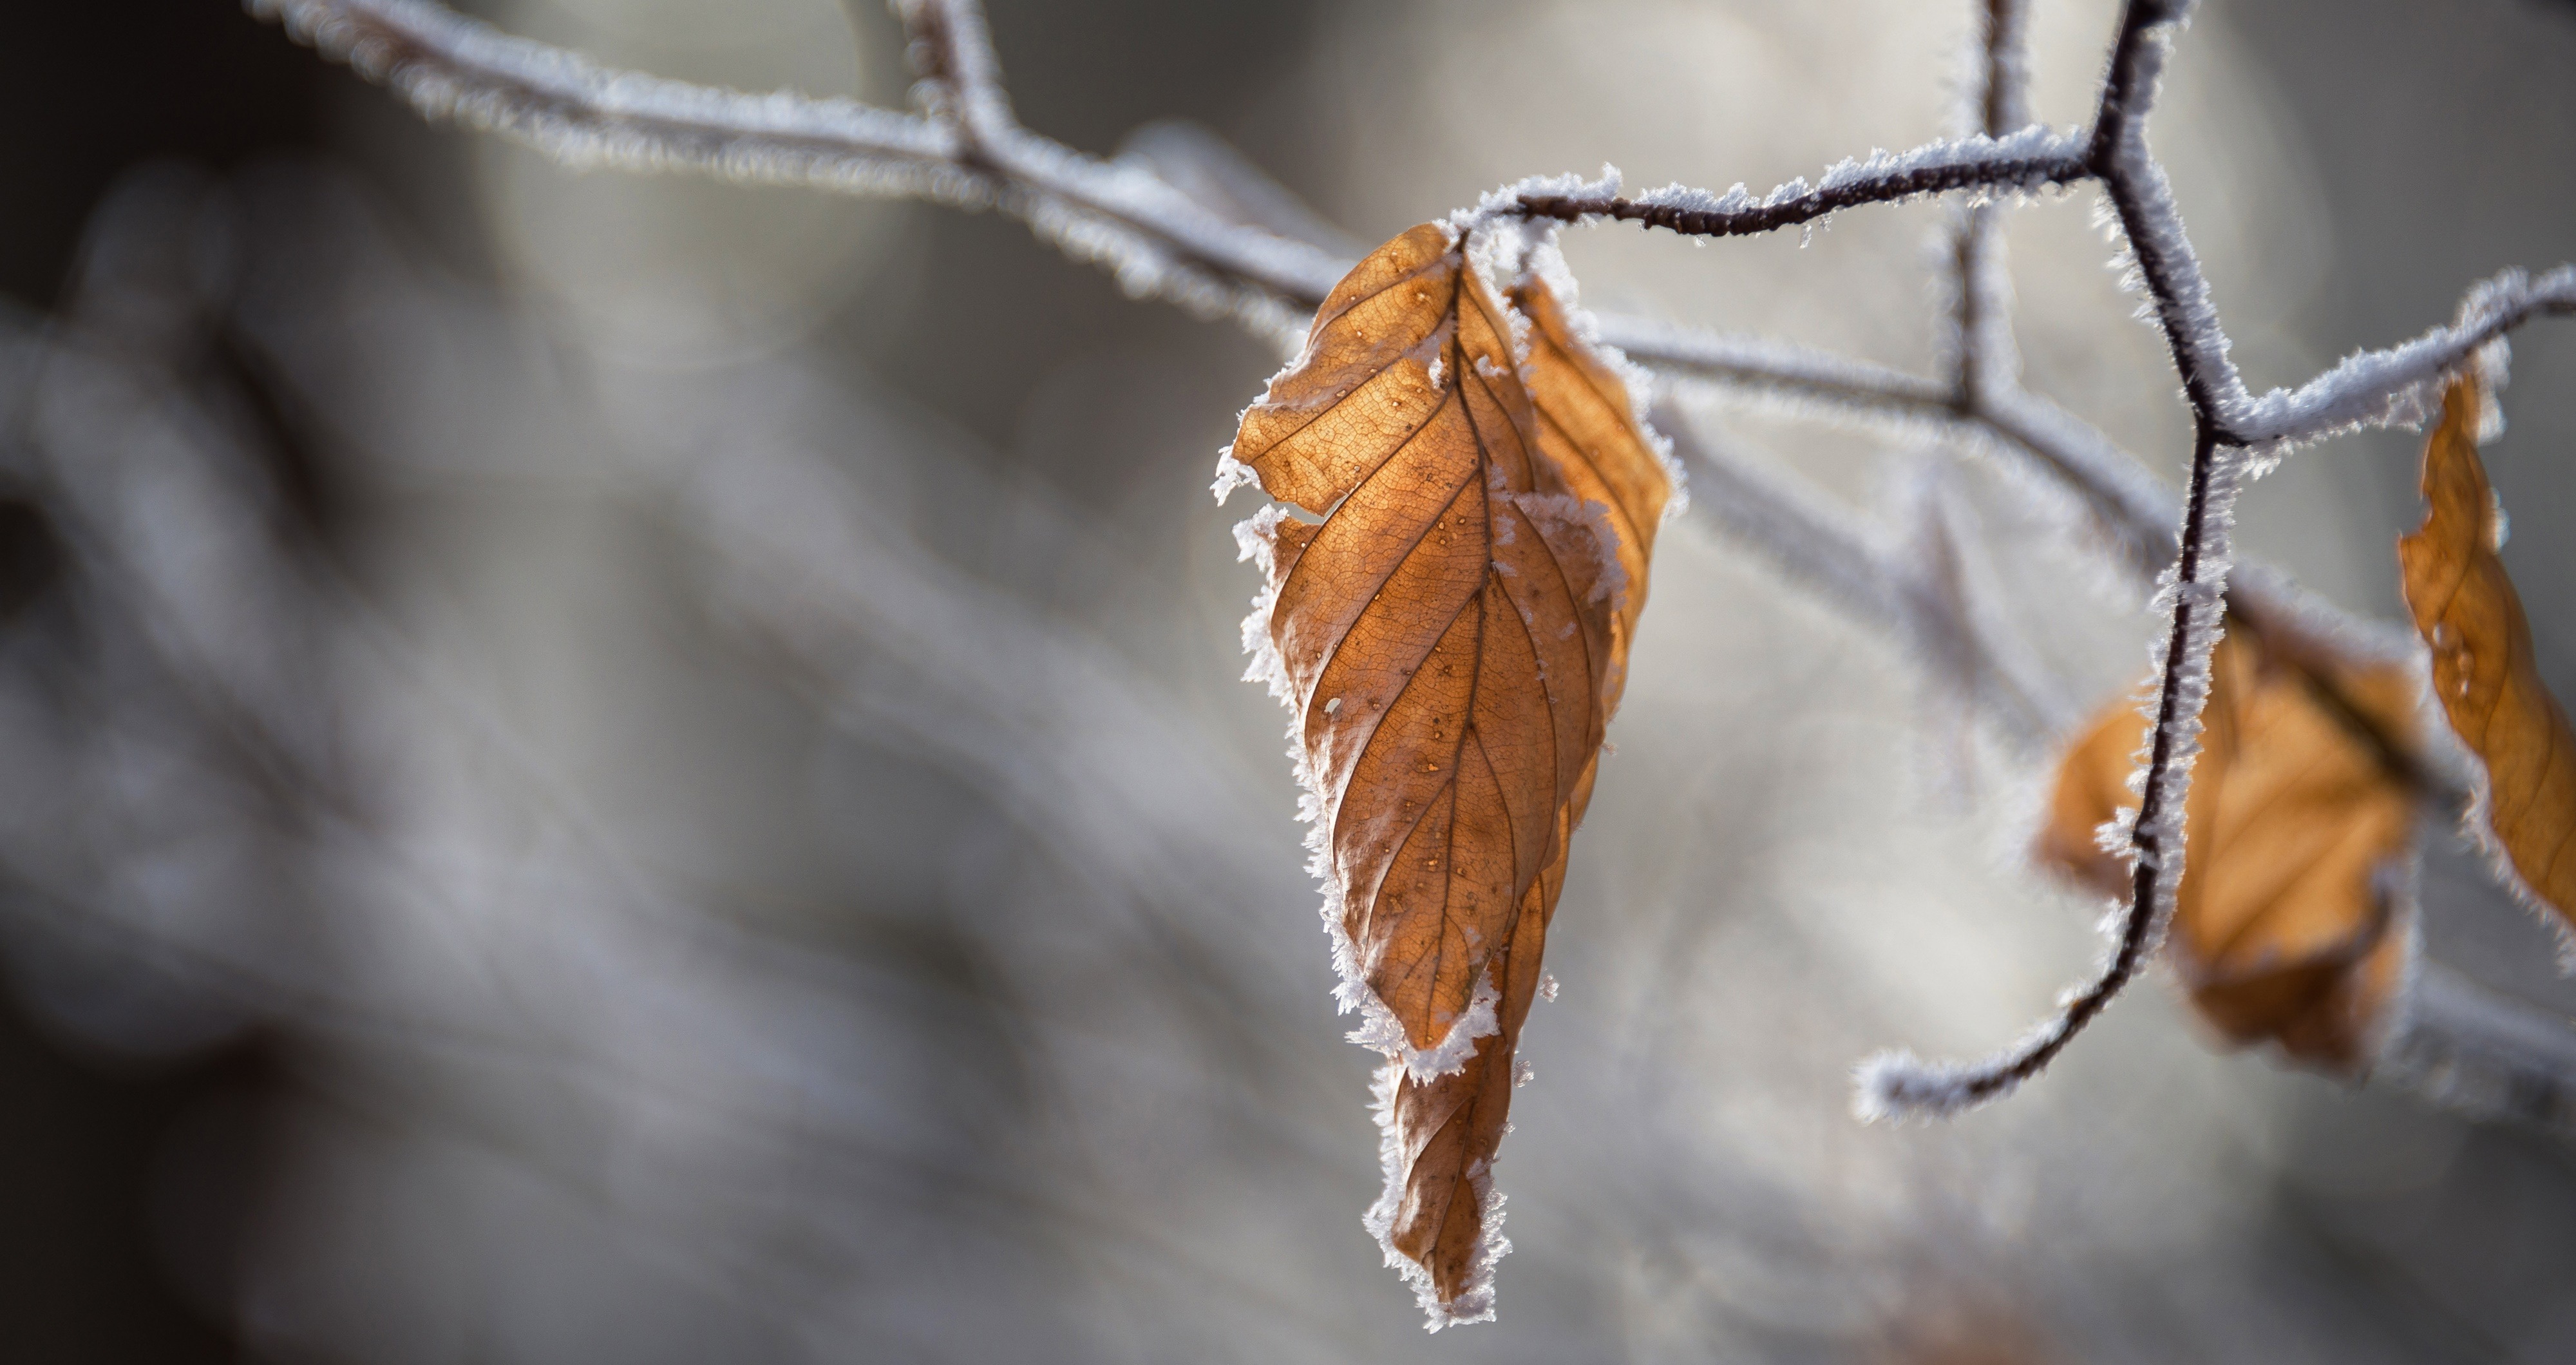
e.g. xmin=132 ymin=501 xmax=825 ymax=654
xmin=2038 ymin=618 xmax=2416 ymax=1074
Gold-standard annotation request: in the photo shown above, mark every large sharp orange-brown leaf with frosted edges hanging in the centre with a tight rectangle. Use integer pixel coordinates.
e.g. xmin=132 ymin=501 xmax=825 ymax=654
xmin=1231 ymin=224 xmax=1669 ymax=1326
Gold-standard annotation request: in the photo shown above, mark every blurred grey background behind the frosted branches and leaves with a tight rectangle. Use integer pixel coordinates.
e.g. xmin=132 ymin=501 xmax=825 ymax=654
xmin=0 ymin=0 xmax=2576 ymax=1365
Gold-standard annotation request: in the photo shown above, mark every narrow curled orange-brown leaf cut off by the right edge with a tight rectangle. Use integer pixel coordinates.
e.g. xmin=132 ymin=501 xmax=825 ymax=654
xmin=2398 ymin=379 xmax=2576 ymax=937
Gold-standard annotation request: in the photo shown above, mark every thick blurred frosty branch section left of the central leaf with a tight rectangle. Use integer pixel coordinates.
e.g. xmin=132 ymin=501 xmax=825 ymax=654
xmin=250 ymin=0 xmax=1347 ymax=338
